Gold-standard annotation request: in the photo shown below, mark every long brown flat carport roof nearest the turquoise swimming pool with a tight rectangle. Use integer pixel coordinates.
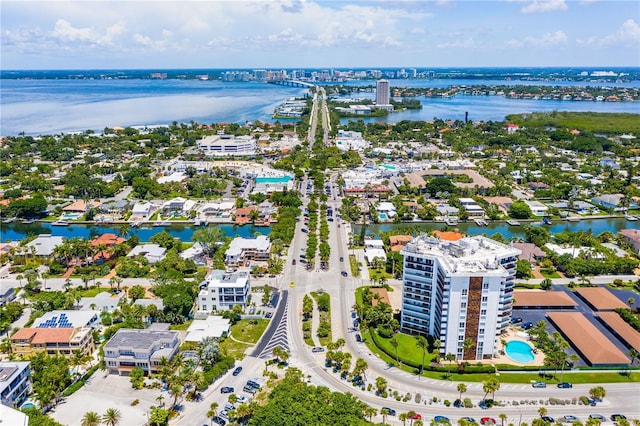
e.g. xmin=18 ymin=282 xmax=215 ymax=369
xmin=547 ymin=312 xmax=630 ymax=365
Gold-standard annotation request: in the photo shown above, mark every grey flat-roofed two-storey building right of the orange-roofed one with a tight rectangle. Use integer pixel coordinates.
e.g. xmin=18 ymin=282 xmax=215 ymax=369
xmin=104 ymin=328 xmax=180 ymax=375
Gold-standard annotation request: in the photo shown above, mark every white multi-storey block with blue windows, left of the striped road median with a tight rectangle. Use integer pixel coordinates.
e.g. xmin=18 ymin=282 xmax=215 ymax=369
xmin=198 ymin=269 xmax=251 ymax=314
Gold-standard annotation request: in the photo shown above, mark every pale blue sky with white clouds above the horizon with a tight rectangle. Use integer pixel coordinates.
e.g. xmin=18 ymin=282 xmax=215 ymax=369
xmin=0 ymin=0 xmax=640 ymax=70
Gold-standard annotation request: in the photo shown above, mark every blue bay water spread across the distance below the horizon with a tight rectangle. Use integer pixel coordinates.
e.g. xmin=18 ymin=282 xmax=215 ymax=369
xmin=0 ymin=73 xmax=640 ymax=135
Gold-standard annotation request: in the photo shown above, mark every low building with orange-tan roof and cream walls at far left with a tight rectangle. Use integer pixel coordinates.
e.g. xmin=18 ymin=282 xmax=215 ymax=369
xmin=11 ymin=327 xmax=94 ymax=358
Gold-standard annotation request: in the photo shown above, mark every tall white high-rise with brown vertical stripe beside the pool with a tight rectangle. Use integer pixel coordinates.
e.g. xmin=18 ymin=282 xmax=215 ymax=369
xmin=400 ymin=235 xmax=520 ymax=360
